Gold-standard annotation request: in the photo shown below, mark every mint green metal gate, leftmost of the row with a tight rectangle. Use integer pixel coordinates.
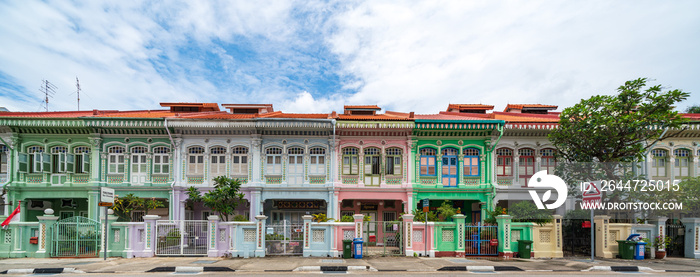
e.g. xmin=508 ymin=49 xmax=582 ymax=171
xmin=51 ymin=216 xmax=101 ymax=257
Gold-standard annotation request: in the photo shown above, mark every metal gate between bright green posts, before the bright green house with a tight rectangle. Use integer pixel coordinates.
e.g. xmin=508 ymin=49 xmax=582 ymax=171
xmin=464 ymin=225 xmax=498 ymax=256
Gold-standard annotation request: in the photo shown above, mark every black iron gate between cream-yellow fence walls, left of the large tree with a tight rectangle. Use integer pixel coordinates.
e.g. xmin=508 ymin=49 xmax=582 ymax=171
xmin=562 ymin=219 xmax=592 ymax=257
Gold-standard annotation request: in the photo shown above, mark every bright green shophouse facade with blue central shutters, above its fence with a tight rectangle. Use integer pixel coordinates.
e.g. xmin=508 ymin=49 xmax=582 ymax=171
xmin=411 ymin=114 xmax=504 ymax=225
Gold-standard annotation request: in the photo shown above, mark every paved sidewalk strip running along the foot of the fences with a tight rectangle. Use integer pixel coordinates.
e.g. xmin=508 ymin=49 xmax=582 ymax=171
xmin=0 ymin=256 xmax=700 ymax=274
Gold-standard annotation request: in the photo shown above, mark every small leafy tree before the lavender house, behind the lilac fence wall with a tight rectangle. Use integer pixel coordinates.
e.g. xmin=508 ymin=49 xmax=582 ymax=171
xmin=187 ymin=176 xmax=243 ymax=221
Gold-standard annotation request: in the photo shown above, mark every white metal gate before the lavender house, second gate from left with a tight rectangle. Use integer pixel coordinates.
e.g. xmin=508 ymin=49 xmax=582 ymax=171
xmin=156 ymin=220 xmax=209 ymax=256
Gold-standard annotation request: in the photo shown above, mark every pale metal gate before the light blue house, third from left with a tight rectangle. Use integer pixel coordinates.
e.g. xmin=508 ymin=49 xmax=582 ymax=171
xmin=265 ymin=220 xmax=304 ymax=255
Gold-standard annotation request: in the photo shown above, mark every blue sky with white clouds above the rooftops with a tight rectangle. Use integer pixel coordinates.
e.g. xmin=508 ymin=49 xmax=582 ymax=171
xmin=0 ymin=0 xmax=700 ymax=113
